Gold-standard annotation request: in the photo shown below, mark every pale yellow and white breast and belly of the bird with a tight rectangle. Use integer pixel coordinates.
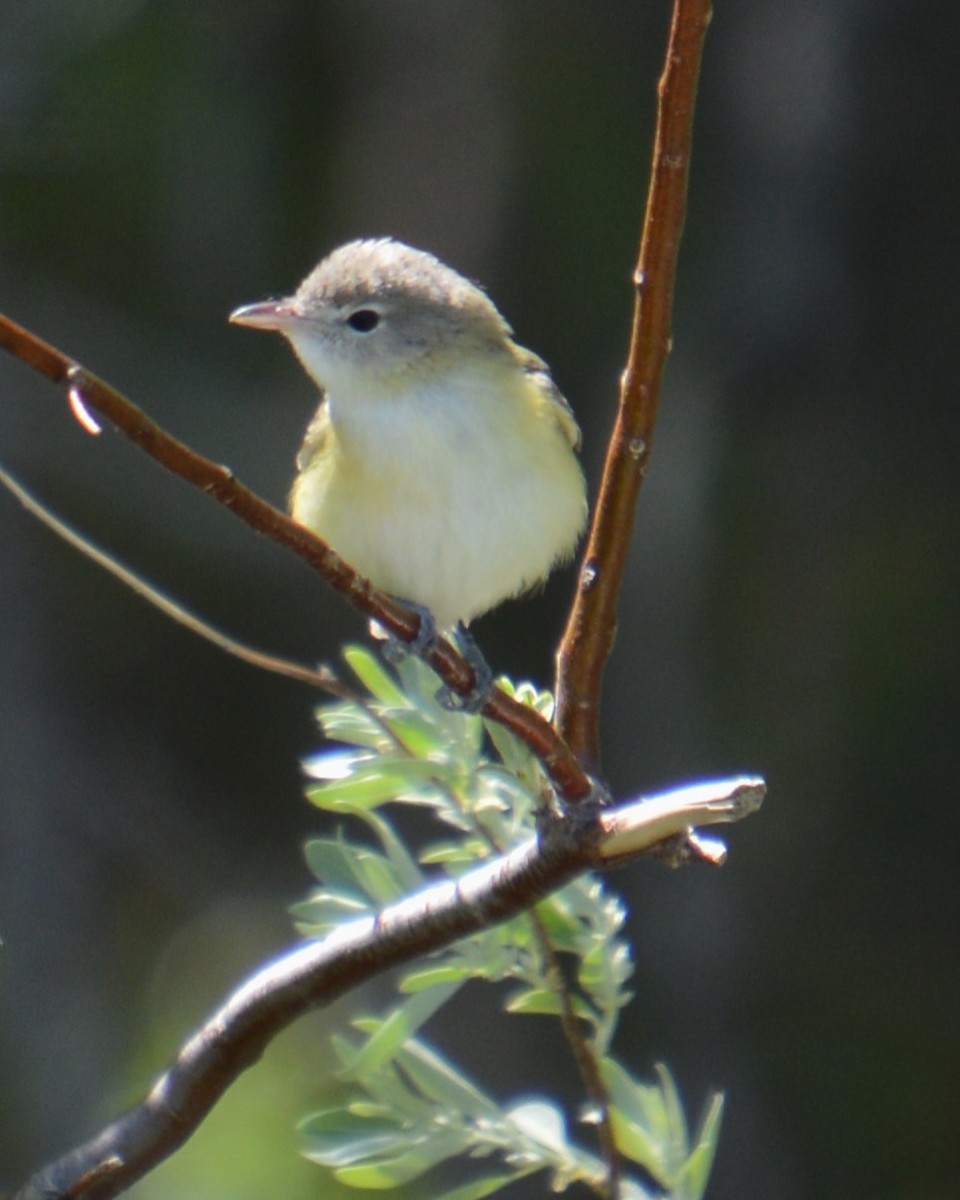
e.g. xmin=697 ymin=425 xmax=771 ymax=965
xmin=294 ymin=372 xmax=586 ymax=628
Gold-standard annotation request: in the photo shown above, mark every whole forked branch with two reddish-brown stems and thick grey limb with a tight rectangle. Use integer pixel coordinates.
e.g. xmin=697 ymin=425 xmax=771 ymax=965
xmin=0 ymin=0 xmax=744 ymax=1200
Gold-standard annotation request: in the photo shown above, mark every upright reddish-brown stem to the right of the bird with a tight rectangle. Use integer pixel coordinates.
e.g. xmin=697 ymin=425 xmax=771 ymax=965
xmin=556 ymin=0 xmax=712 ymax=764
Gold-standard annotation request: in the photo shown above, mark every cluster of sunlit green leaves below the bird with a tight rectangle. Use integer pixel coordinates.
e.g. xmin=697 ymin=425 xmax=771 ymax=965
xmin=294 ymin=648 xmax=720 ymax=1200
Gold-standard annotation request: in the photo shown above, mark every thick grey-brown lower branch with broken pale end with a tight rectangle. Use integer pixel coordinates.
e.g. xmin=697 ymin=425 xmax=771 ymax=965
xmin=13 ymin=778 xmax=764 ymax=1200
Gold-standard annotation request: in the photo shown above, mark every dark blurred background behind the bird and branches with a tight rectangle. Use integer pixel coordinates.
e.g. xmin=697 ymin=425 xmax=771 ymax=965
xmin=0 ymin=0 xmax=960 ymax=1200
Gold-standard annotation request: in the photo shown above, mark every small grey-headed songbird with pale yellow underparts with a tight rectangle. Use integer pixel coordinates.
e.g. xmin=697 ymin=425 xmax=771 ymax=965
xmin=230 ymin=239 xmax=587 ymax=629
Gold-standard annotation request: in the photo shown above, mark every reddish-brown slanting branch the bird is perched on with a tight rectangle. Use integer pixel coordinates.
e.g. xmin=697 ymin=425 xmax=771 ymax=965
xmin=0 ymin=313 xmax=593 ymax=804
